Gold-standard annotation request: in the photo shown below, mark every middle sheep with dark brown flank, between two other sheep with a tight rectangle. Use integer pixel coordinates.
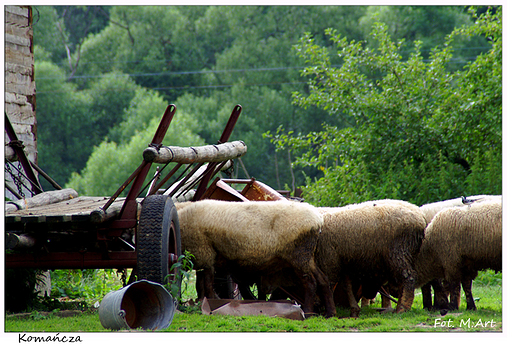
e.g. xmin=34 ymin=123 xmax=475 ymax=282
xmin=316 ymin=200 xmax=426 ymax=316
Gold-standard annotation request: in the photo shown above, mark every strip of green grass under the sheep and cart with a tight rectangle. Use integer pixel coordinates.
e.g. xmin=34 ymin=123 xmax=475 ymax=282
xmin=5 ymin=274 xmax=502 ymax=333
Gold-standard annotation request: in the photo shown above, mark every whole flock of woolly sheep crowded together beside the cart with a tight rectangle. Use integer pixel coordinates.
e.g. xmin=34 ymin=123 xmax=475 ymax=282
xmin=176 ymin=195 xmax=502 ymax=317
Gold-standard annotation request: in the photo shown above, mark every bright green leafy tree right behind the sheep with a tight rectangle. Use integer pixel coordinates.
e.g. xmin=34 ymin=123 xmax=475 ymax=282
xmin=271 ymin=5 xmax=501 ymax=206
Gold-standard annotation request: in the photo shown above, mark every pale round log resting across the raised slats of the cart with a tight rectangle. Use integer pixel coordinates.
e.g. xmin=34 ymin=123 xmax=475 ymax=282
xmin=143 ymin=141 xmax=247 ymax=163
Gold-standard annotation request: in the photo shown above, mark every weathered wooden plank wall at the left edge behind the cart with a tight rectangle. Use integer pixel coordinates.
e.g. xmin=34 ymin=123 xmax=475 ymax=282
xmin=4 ymin=6 xmax=38 ymax=197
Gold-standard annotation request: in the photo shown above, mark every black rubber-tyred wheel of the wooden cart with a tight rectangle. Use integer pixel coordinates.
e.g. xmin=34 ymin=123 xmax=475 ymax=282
xmin=137 ymin=195 xmax=182 ymax=299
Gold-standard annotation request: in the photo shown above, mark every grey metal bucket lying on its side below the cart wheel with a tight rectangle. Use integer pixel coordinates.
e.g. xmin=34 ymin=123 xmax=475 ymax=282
xmin=99 ymin=280 xmax=175 ymax=330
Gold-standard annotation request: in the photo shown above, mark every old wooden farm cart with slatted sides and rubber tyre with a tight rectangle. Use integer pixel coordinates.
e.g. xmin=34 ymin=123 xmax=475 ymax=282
xmin=5 ymin=105 xmax=247 ymax=290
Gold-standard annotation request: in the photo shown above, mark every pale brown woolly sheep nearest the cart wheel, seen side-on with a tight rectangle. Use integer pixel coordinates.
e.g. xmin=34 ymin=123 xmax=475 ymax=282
xmin=177 ymin=200 xmax=336 ymax=317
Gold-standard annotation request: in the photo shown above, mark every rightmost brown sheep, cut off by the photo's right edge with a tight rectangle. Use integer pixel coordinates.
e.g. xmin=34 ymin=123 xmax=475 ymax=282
xmin=416 ymin=199 xmax=502 ymax=310
